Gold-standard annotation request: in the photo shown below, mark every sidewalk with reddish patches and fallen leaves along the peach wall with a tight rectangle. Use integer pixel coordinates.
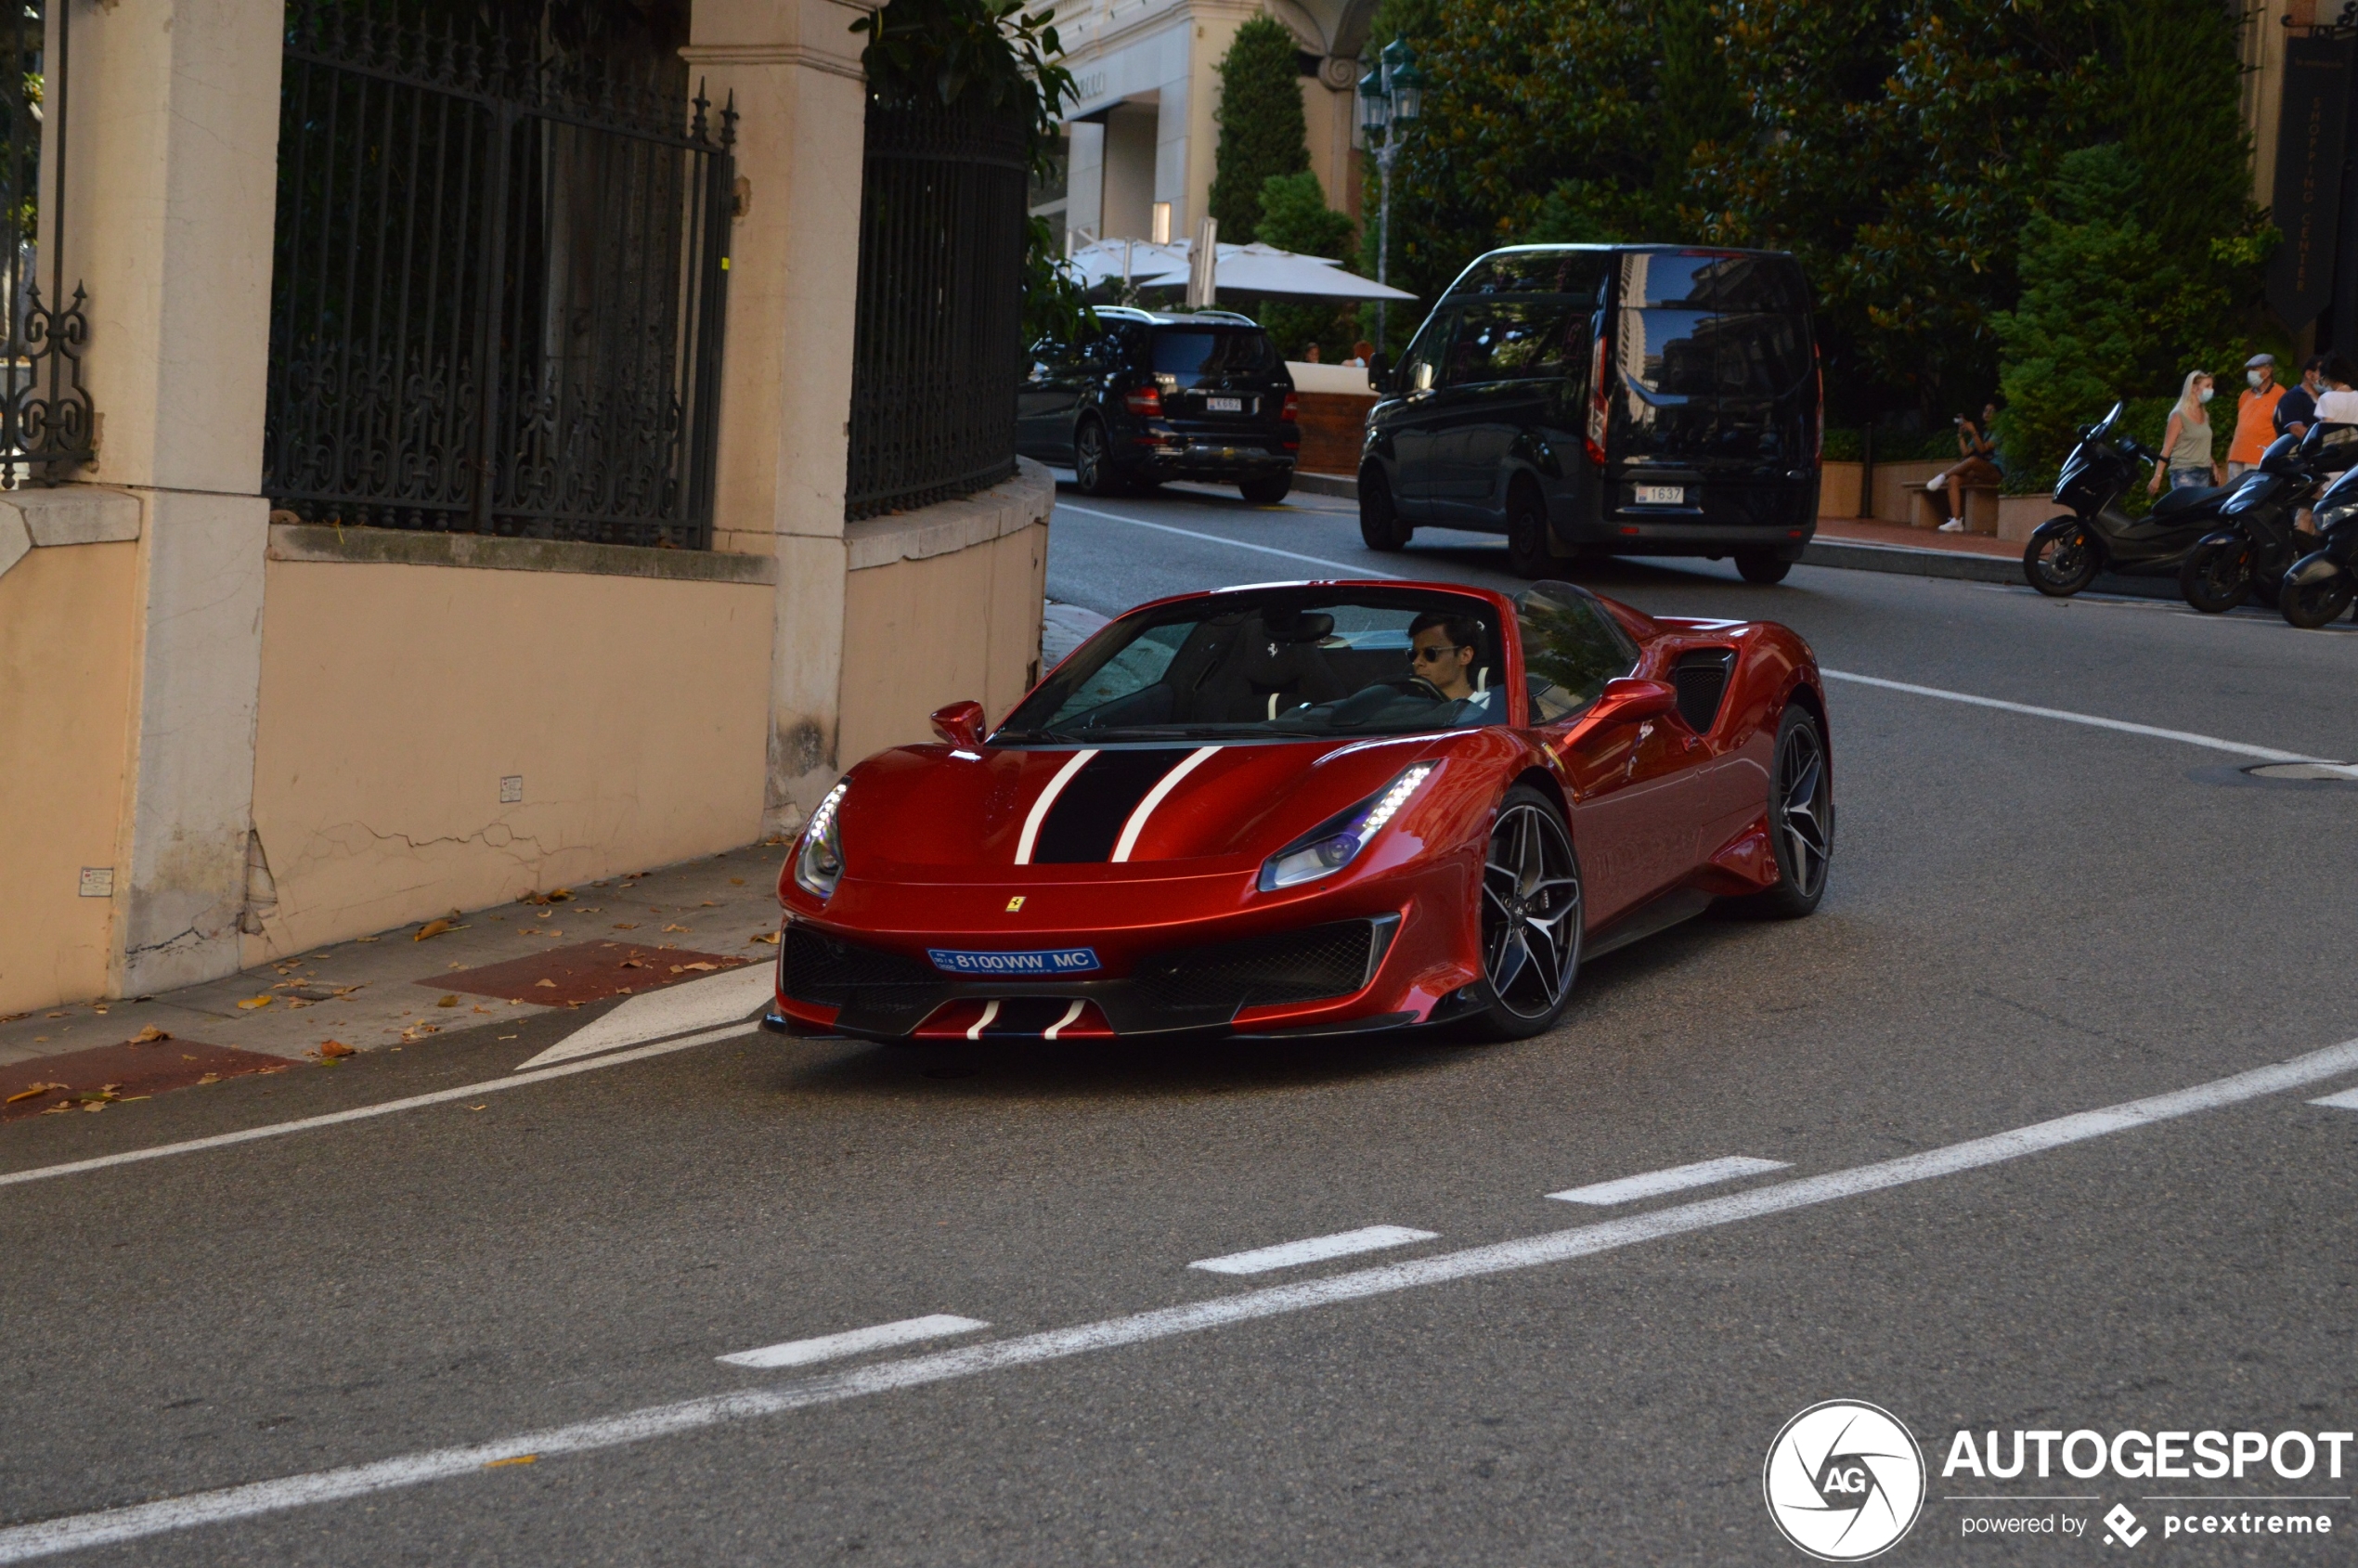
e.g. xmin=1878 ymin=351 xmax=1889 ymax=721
xmin=0 ymin=844 xmax=785 ymax=1122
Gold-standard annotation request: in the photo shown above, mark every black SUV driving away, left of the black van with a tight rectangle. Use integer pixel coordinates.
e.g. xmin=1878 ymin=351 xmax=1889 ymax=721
xmin=1017 ymin=306 xmax=1302 ymax=505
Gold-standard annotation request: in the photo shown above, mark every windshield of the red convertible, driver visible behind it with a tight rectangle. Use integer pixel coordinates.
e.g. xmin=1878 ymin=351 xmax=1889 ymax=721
xmin=992 ymin=587 xmax=1507 ymax=745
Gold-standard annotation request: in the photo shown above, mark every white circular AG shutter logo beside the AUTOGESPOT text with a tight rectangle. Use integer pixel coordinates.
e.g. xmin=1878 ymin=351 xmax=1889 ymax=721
xmin=1761 ymin=1398 xmax=1924 ymax=1563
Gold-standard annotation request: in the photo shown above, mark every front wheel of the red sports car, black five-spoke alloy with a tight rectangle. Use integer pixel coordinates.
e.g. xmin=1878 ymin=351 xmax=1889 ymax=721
xmin=1481 ymin=785 xmax=1585 ymax=1040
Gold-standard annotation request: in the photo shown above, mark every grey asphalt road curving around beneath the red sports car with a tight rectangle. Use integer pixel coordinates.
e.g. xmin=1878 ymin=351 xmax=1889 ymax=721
xmin=0 ymin=493 xmax=2358 ymax=1568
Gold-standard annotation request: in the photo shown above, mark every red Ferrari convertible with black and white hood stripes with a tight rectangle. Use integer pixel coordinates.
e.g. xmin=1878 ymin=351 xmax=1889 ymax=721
xmin=771 ymin=582 xmax=1834 ymax=1043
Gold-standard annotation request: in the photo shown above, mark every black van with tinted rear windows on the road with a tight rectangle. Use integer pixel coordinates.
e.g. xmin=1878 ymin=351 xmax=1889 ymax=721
xmin=1358 ymin=245 xmax=1822 ymax=582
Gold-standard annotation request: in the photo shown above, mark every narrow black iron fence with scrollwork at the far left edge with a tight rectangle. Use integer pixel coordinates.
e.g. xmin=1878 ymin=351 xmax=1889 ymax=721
xmin=0 ymin=0 xmax=97 ymax=490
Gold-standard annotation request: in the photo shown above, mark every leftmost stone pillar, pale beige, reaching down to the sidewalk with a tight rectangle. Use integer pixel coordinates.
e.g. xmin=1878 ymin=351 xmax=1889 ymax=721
xmin=52 ymin=0 xmax=283 ymax=992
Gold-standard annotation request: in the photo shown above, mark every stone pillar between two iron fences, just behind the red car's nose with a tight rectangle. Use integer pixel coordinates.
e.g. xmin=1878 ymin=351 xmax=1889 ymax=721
xmin=681 ymin=0 xmax=875 ymax=833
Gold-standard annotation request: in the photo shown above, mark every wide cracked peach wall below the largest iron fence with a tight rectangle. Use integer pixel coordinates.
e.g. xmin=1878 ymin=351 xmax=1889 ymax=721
xmin=245 ymin=561 xmax=773 ymax=962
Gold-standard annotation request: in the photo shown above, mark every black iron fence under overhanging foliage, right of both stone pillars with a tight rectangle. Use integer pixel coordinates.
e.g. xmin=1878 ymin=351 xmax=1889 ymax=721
xmin=844 ymin=99 xmax=1030 ymax=519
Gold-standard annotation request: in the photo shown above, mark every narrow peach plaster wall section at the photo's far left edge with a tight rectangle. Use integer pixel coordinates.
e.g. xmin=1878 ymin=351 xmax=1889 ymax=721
xmin=0 ymin=542 xmax=139 ymax=1014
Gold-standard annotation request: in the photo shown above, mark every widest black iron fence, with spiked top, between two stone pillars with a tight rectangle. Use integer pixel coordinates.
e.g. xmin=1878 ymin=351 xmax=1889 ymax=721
xmin=262 ymin=0 xmax=735 ymax=550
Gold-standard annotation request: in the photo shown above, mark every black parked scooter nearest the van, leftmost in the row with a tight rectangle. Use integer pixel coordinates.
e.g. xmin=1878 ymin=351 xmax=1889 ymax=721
xmin=2023 ymin=403 xmax=2231 ymax=599
